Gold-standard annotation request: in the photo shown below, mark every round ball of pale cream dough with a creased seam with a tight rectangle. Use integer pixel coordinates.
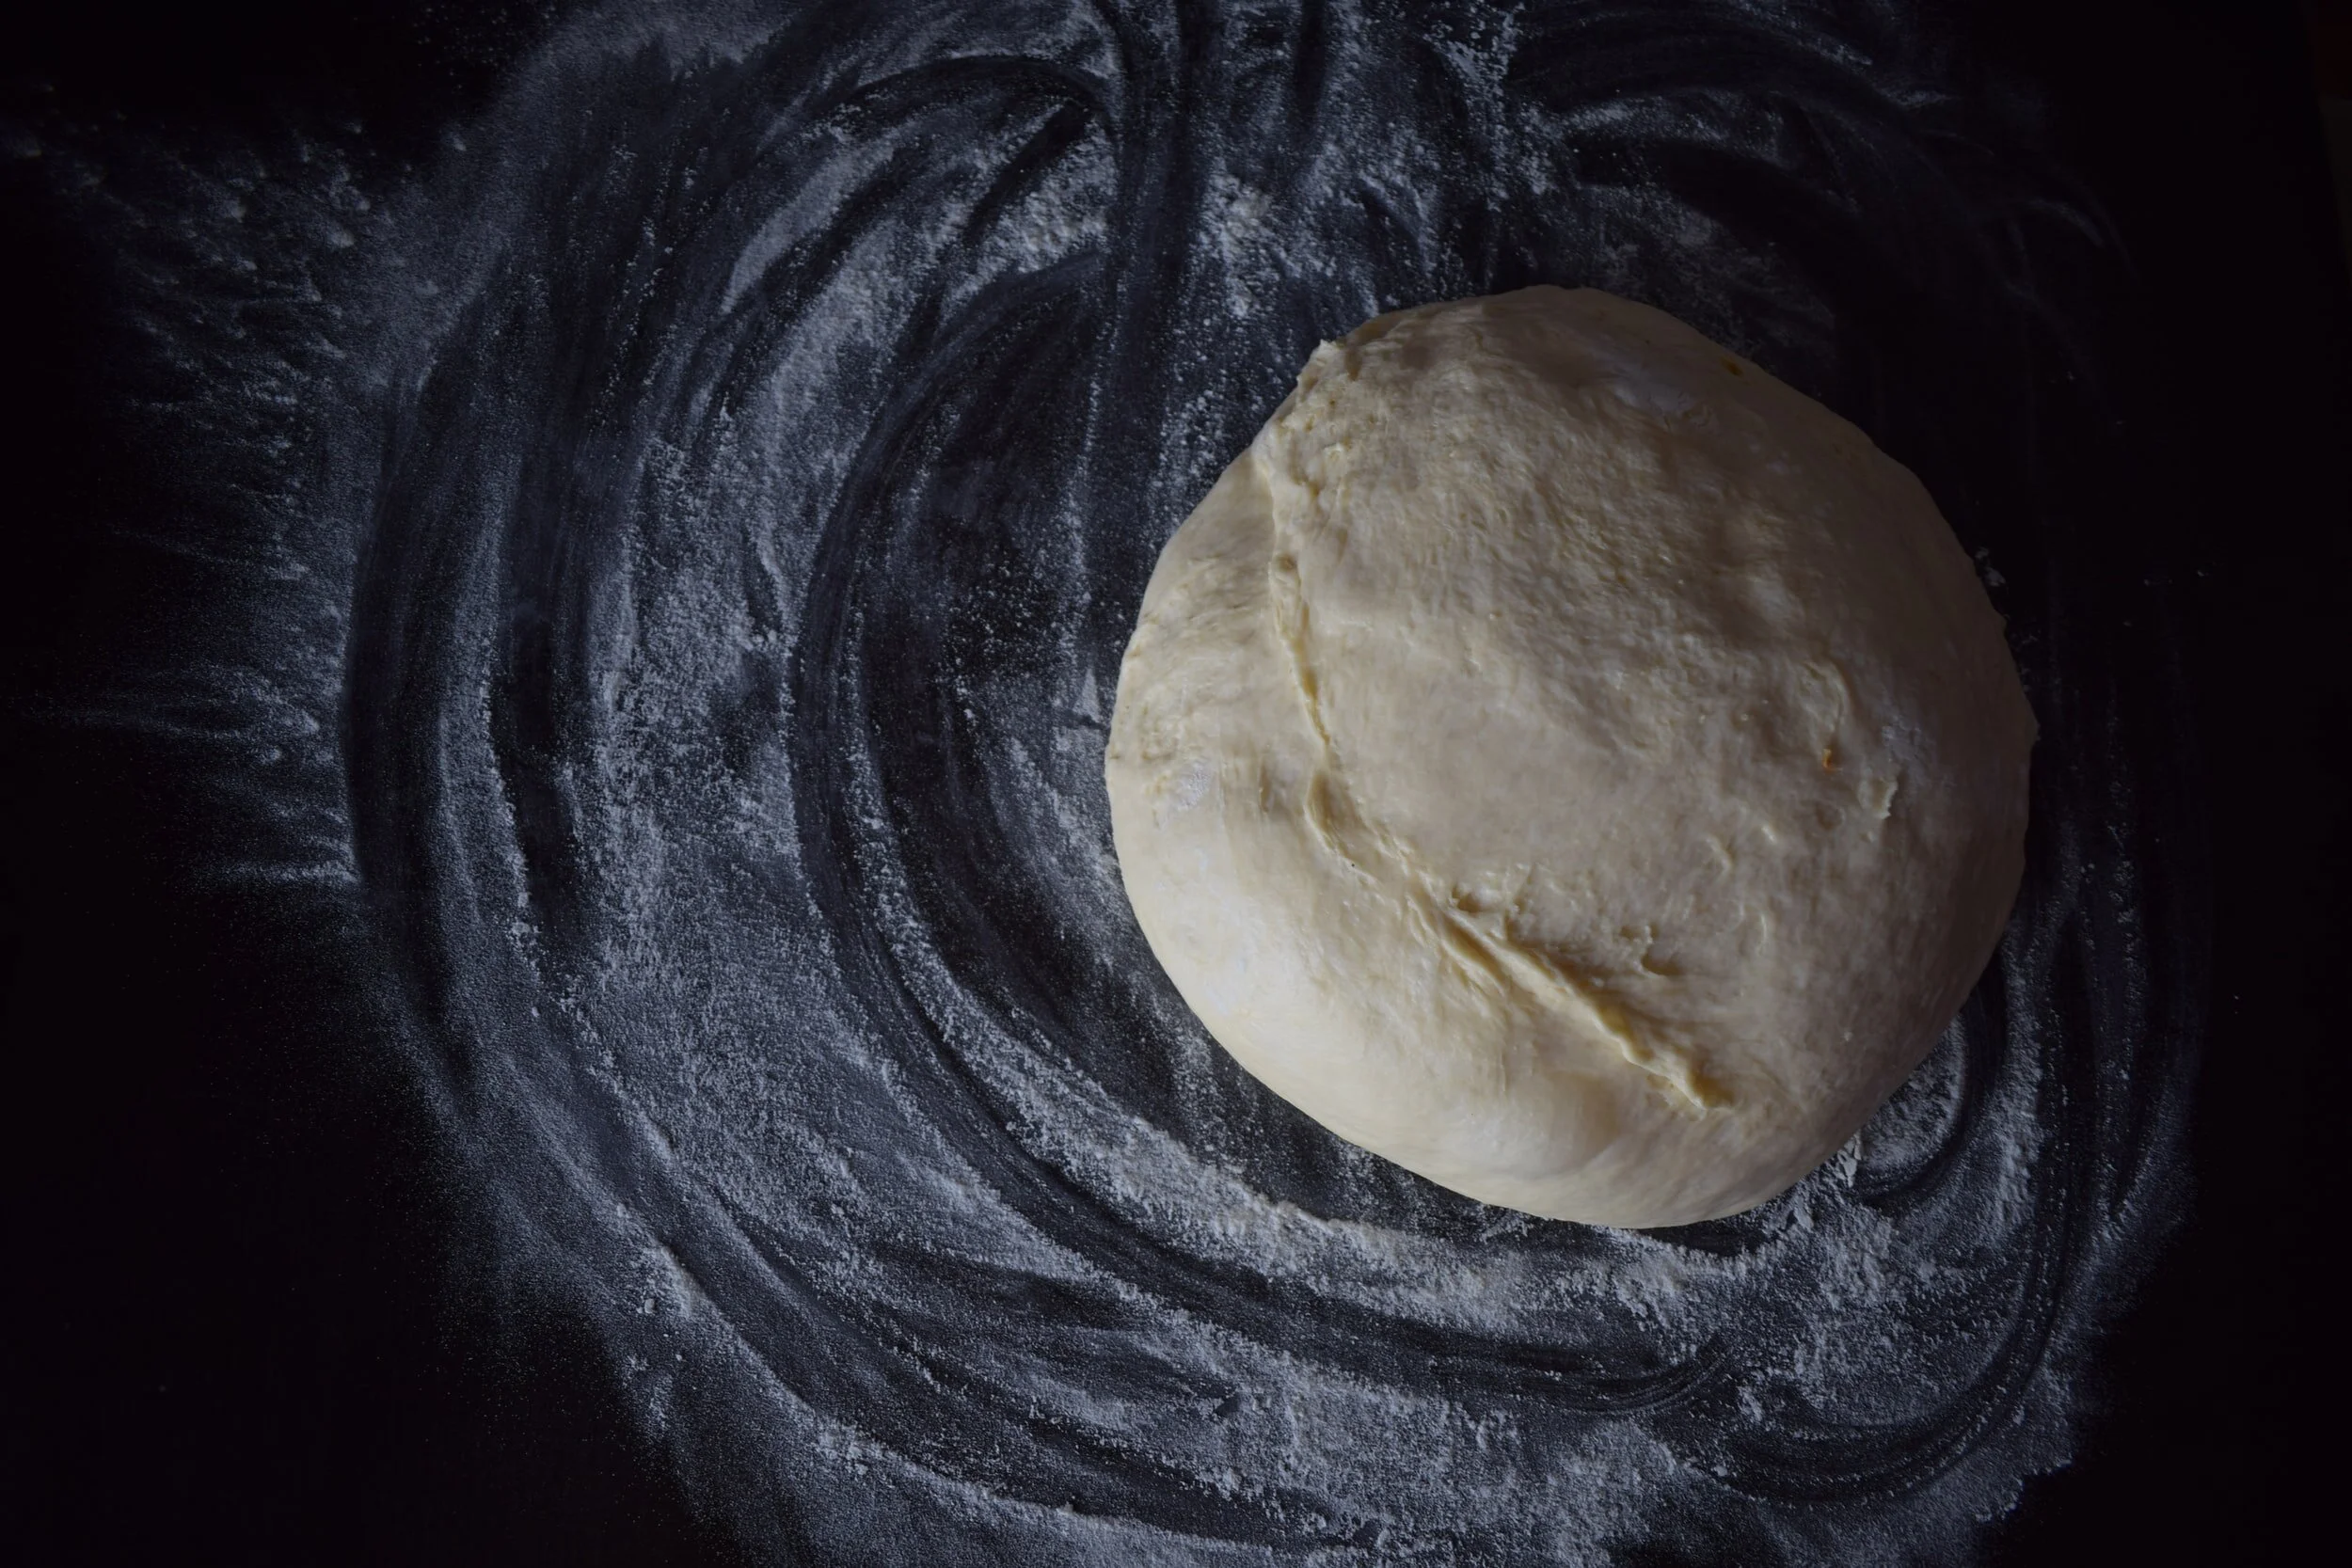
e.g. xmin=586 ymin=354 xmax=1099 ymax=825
xmin=1105 ymin=287 xmax=2035 ymax=1225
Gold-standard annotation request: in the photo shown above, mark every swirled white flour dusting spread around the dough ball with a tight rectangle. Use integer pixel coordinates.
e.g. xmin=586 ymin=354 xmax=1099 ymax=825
xmin=32 ymin=0 xmax=2201 ymax=1563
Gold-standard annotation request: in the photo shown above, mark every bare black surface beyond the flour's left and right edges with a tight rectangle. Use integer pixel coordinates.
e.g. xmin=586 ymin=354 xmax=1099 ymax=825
xmin=0 ymin=0 xmax=2352 ymax=1563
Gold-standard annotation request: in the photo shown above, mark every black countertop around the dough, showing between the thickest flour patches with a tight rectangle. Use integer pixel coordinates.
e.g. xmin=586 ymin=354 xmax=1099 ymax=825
xmin=0 ymin=5 xmax=2352 ymax=1563
